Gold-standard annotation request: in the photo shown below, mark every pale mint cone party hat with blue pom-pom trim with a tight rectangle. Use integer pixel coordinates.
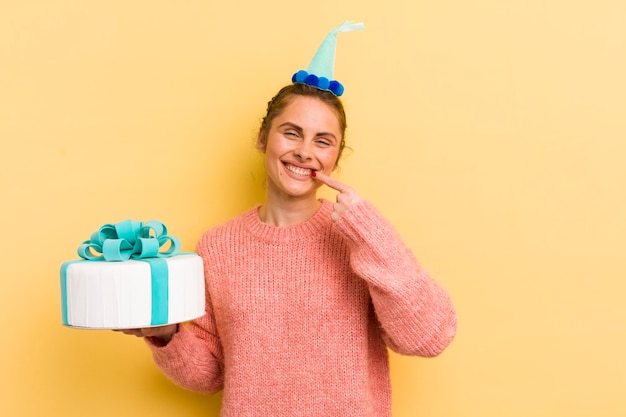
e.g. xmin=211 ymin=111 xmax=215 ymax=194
xmin=291 ymin=21 xmax=365 ymax=96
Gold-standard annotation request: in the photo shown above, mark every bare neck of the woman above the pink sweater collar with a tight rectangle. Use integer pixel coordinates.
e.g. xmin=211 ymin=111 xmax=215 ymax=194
xmin=259 ymin=193 xmax=322 ymax=226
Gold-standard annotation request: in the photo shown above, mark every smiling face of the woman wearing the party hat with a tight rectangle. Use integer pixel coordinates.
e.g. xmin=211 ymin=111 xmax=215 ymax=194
xmin=257 ymin=95 xmax=343 ymax=198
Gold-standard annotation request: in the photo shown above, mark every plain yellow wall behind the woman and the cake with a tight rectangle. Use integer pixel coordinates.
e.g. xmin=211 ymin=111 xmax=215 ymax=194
xmin=0 ymin=0 xmax=626 ymax=417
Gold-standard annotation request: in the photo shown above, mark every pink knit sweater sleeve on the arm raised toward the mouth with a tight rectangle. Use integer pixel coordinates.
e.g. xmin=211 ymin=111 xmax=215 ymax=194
xmin=335 ymin=201 xmax=456 ymax=357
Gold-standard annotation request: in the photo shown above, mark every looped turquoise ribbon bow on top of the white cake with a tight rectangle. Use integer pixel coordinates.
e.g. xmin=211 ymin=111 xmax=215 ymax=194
xmin=78 ymin=220 xmax=181 ymax=262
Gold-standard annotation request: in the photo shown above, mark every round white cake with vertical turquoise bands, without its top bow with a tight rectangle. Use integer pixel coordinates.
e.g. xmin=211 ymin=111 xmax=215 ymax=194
xmin=61 ymin=253 xmax=205 ymax=329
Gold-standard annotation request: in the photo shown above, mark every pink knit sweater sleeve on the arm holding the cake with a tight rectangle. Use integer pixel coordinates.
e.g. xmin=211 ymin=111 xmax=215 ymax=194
xmin=146 ymin=262 xmax=224 ymax=394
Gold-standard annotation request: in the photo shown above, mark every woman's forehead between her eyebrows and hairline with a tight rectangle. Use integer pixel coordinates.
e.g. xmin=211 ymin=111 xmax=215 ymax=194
xmin=273 ymin=96 xmax=341 ymax=133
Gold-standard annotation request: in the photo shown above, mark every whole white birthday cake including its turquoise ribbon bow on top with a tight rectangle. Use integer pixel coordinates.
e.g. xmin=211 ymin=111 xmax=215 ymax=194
xmin=61 ymin=220 xmax=205 ymax=329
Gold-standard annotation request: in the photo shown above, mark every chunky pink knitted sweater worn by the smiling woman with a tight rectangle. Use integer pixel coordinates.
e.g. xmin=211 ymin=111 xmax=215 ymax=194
xmin=148 ymin=200 xmax=456 ymax=417
